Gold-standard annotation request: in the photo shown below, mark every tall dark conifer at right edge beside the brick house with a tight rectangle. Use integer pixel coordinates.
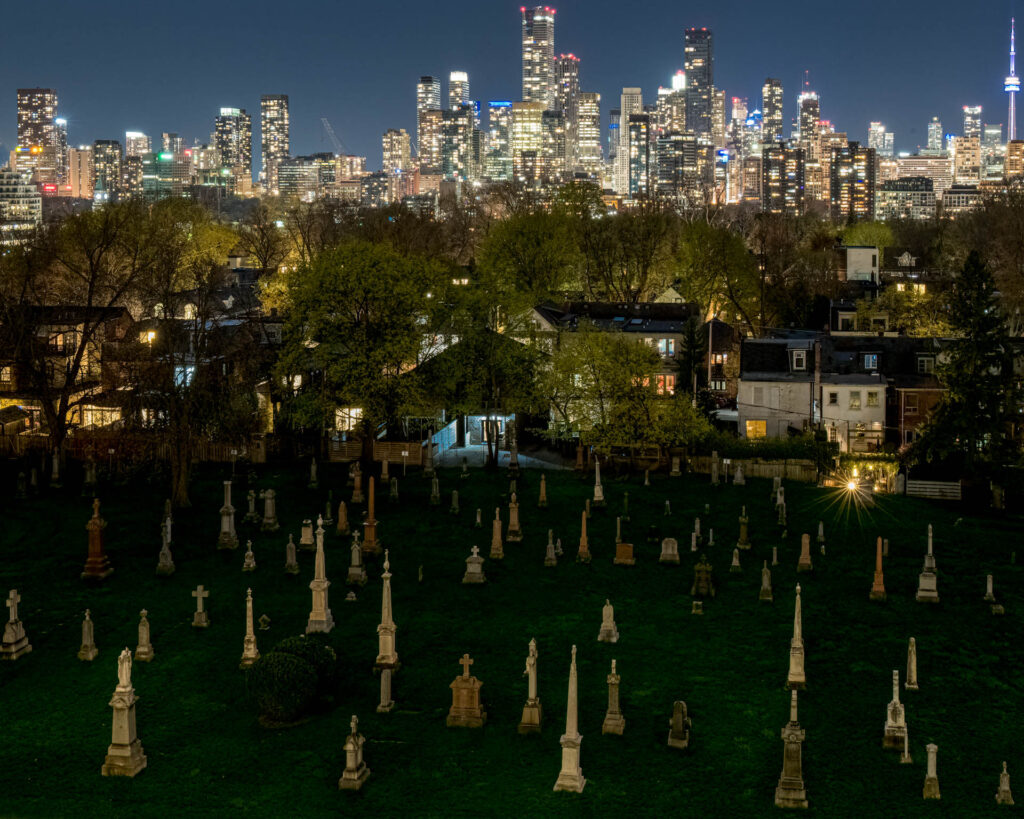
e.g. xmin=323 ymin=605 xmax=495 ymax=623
xmin=918 ymin=252 xmax=1021 ymax=474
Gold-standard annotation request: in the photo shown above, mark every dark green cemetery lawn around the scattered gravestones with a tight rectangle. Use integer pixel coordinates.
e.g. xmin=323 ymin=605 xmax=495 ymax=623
xmin=0 ymin=465 xmax=1024 ymax=817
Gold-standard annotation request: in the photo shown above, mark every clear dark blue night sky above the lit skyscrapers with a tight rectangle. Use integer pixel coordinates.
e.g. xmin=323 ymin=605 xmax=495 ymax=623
xmin=0 ymin=0 xmax=1024 ymax=169
